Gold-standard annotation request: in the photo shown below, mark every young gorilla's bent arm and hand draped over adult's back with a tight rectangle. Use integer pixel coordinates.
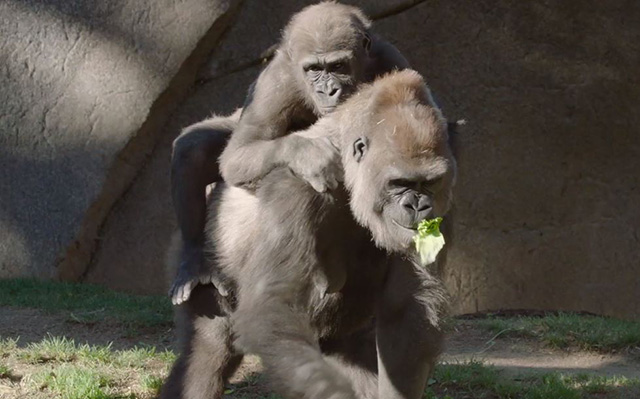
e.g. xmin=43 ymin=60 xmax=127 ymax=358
xmin=219 ymin=53 xmax=339 ymax=191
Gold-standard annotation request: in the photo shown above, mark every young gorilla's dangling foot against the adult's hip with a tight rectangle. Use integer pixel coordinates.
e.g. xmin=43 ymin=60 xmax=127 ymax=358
xmin=169 ymin=251 xmax=229 ymax=305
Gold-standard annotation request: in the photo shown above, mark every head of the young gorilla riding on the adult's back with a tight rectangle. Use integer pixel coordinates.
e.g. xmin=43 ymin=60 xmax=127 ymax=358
xmin=281 ymin=2 xmax=371 ymax=115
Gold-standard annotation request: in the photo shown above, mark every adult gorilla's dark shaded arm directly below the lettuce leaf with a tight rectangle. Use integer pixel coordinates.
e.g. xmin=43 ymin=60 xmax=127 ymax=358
xmin=376 ymin=260 xmax=446 ymax=399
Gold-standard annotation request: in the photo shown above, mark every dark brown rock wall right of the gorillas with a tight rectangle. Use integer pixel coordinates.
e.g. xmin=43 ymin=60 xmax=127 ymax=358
xmin=378 ymin=0 xmax=640 ymax=317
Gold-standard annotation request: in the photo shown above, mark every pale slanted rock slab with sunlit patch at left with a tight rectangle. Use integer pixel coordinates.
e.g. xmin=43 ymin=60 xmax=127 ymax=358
xmin=0 ymin=0 xmax=238 ymax=278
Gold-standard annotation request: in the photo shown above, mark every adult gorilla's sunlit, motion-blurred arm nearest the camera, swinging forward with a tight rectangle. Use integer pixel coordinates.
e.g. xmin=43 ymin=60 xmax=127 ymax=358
xmin=232 ymin=170 xmax=355 ymax=399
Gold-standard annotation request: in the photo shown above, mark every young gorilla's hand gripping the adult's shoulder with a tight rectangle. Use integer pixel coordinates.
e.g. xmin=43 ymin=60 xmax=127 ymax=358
xmin=288 ymin=135 xmax=343 ymax=193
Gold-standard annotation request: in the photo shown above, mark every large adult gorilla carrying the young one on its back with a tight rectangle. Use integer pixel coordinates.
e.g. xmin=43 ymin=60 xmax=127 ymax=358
xmin=161 ymin=70 xmax=455 ymax=399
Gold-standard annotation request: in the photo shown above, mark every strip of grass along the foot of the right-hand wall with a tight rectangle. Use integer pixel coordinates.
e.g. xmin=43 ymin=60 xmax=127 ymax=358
xmin=474 ymin=313 xmax=640 ymax=352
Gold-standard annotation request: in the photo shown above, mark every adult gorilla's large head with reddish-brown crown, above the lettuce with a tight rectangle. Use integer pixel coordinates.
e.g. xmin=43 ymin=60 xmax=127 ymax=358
xmin=336 ymin=70 xmax=456 ymax=251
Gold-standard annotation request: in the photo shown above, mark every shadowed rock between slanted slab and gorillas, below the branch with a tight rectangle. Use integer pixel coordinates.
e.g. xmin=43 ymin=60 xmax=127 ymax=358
xmin=87 ymin=68 xmax=259 ymax=293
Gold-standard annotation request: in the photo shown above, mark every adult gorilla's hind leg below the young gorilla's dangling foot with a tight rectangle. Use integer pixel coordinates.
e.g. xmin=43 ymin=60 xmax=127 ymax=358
xmin=160 ymin=284 xmax=243 ymax=399
